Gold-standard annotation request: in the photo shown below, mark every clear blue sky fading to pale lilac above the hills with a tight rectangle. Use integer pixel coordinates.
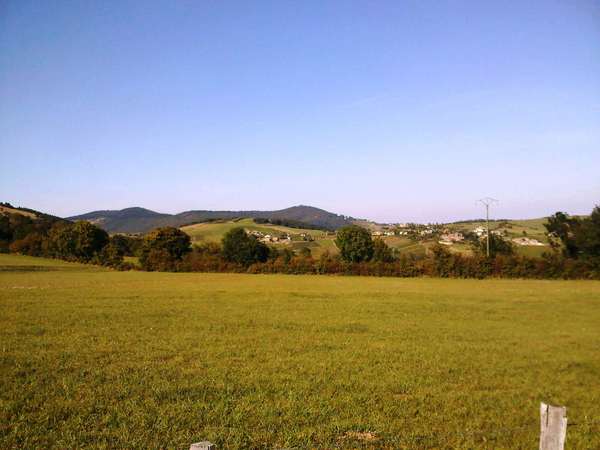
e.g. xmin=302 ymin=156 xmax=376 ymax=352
xmin=0 ymin=0 xmax=600 ymax=221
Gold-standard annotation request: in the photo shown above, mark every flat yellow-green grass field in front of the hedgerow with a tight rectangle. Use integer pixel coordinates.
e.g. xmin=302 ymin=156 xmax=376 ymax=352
xmin=0 ymin=255 xmax=600 ymax=449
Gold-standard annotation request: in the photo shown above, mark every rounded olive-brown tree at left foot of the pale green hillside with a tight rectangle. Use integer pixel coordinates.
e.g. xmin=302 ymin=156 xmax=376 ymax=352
xmin=140 ymin=227 xmax=191 ymax=270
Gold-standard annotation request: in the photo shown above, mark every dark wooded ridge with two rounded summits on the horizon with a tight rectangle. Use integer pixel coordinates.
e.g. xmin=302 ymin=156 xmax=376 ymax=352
xmin=68 ymin=205 xmax=354 ymax=233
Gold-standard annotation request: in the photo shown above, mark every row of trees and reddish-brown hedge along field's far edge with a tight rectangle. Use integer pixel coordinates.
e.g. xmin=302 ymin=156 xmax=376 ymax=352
xmin=0 ymin=207 xmax=600 ymax=279
